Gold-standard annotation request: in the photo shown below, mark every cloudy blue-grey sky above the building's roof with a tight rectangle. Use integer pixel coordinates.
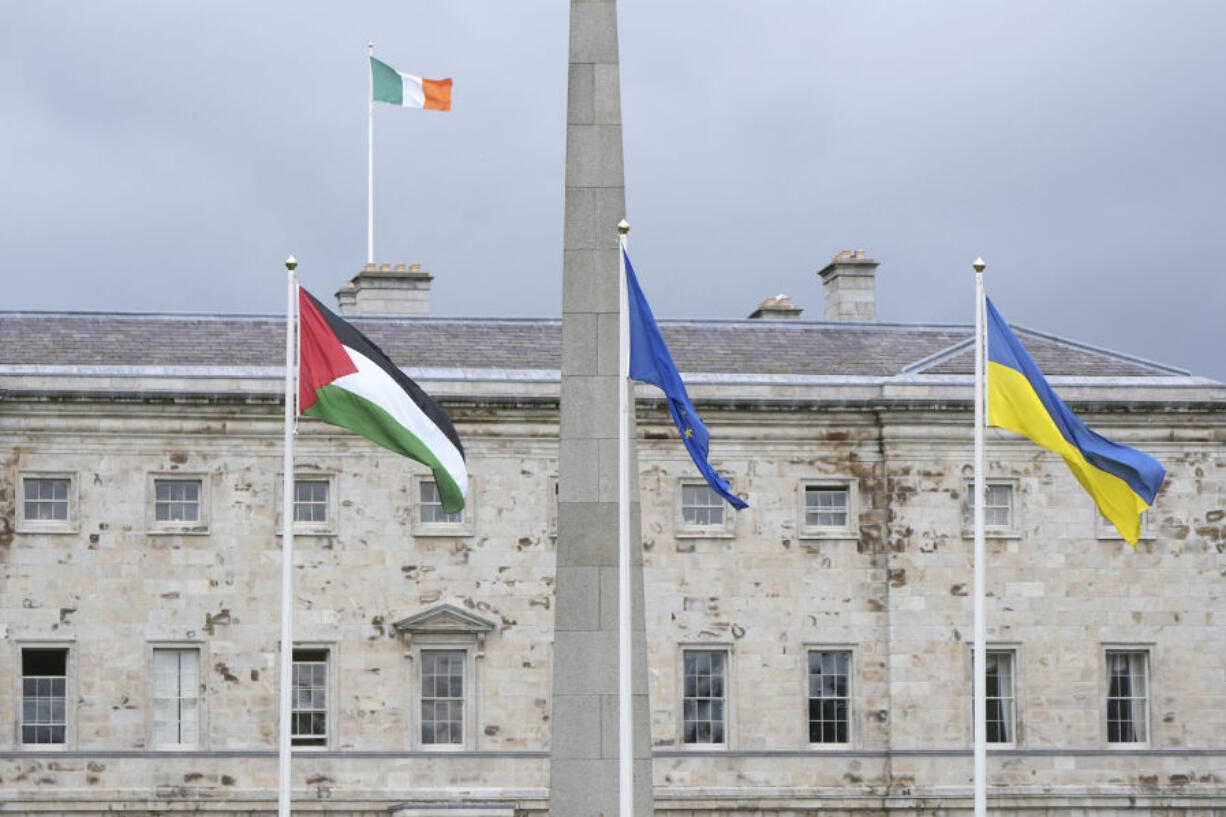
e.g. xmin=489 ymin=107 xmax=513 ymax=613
xmin=0 ymin=0 xmax=1226 ymax=380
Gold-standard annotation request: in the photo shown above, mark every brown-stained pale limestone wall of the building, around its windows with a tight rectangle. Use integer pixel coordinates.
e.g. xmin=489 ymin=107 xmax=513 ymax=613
xmin=0 ymin=385 xmax=1226 ymax=815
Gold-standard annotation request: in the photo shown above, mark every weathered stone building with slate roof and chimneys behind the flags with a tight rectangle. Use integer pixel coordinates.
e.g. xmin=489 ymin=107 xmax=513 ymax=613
xmin=0 ymin=253 xmax=1226 ymax=817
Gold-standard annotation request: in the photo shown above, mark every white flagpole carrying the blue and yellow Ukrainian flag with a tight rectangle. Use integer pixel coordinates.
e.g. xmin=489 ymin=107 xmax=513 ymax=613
xmin=973 ymin=258 xmax=988 ymax=817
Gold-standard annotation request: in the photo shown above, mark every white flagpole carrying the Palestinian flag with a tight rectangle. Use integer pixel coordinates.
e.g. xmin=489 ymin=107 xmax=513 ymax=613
xmin=277 ymin=255 xmax=298 ymax=817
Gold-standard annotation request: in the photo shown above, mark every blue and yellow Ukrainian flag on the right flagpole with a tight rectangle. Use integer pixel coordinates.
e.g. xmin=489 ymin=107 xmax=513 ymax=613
xmin=987 ymin=298 xmax=1166 ymax=548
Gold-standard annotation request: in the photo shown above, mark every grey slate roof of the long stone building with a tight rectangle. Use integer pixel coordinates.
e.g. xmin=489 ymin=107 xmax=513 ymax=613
xmin=0 ymin=312 xmax=1186 ymax=377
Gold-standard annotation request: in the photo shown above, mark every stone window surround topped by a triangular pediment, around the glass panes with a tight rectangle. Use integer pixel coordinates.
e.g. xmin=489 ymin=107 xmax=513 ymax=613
xmin=394 ymin=604 xmax=497 ymax=752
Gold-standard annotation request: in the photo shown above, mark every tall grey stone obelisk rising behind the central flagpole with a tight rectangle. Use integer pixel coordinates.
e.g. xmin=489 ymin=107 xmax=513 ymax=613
xmin=549 ymin=0 xmax=652 ymax=817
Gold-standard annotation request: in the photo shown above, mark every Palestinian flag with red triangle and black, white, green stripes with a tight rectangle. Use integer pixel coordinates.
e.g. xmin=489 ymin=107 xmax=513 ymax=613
xmin=298 ymin=287 xmax=468 ymax=514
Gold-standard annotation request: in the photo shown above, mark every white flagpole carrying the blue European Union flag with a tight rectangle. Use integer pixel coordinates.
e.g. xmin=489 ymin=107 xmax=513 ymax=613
xmin=617 ymin=218 xmax=634 ymax=817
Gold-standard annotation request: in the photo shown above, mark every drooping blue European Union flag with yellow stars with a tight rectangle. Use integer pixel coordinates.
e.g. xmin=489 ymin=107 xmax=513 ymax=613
xmin=622 ymin=250 xmax=749 ymax=510
